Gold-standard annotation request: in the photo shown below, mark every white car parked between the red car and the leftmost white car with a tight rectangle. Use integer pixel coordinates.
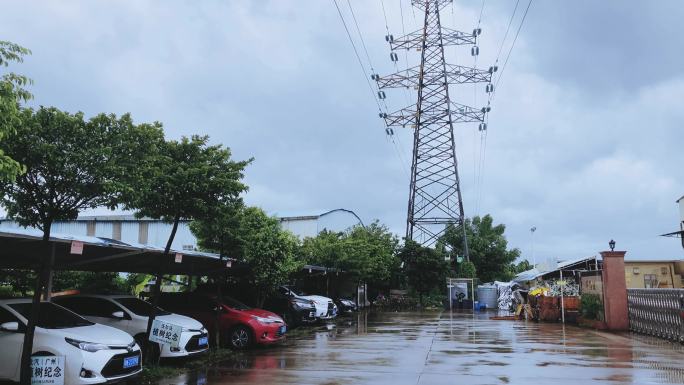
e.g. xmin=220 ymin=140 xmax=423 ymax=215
xmin=52 ymin=294 xmax=209 ymax=358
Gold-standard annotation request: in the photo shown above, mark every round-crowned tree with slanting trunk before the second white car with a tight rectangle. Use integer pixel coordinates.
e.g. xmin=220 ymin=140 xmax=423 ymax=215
xmin=124 ymin=136 xmax=251 ymax=362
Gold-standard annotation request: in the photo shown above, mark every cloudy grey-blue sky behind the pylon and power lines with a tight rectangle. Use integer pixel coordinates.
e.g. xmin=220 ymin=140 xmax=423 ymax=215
xmin=0 ymin=0 xmax=684 ymax=259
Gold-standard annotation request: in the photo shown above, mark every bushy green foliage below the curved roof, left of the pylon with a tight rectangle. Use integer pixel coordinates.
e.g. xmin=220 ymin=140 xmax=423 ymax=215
xmin=300 ymin=221 xmax=400 ymax=286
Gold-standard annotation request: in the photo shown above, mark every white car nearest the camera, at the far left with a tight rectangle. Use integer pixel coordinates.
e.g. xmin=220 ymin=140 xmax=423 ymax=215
xmin=0 ymin=299 xmax=142 ymax=384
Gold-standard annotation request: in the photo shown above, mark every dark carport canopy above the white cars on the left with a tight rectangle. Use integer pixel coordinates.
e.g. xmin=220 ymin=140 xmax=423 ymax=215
xmin=0 ymin=229 xmax=229 ymax=275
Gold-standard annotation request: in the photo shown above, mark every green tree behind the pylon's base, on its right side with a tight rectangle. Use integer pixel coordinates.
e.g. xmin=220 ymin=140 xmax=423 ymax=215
xmin=441 ymin=215 xmax=520 ymax=282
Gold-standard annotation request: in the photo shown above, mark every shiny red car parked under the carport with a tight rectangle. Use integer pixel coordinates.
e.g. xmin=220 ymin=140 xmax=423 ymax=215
xmin=159 ymin=293 xmax=287 ymax=349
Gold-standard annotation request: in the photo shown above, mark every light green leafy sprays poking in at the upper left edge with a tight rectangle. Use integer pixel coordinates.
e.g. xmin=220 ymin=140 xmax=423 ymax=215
xmin=0 ymin=41 xmax=32 ymax=181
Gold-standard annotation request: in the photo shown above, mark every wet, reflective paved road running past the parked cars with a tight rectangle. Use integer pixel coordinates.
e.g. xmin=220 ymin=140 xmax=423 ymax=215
xmin=152 ymin=311 xmax=684 ymax=385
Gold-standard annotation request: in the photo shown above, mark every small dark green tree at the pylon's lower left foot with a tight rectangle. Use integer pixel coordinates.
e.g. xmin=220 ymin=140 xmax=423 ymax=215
xmin=399 ymin=240 xmax=449 ymax=305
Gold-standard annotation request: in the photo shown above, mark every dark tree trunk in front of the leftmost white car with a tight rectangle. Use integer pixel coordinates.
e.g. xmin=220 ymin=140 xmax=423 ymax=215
xmin=20 ymin=221 xmax=55 ymax=385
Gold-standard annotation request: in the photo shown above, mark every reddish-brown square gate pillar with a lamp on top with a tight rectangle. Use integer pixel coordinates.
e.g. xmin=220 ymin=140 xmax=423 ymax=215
xmin=601 ymin=251 xmax=629 ymax=330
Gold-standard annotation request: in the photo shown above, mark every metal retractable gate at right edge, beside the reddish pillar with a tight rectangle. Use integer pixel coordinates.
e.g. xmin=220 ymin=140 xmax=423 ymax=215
xmin=627 ymin=289 xmax=684 ymax=343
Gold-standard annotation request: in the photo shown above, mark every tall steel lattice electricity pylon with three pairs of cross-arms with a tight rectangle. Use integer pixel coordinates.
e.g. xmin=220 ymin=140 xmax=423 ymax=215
xmin=372 ymin=0 xmax=497 ymax=255
